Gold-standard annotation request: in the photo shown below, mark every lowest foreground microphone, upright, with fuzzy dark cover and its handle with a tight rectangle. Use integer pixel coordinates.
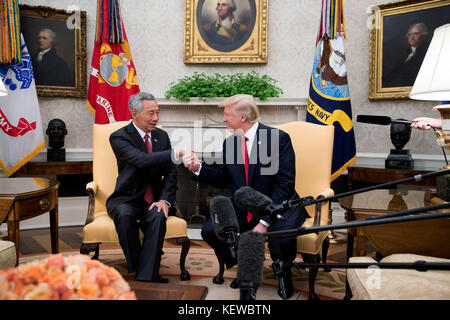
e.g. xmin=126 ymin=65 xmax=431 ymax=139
xmin=237 ymin=231 xmax=265 ymax=300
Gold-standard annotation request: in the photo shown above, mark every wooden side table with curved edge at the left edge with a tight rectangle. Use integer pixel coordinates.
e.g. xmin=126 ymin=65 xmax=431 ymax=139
xmin=0 ymin=178 xmax=59 ymax=265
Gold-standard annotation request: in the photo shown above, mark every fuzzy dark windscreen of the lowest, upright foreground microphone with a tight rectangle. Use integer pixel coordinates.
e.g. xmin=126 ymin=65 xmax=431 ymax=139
xmin=237 ymin=231 xmax=265 ymax=284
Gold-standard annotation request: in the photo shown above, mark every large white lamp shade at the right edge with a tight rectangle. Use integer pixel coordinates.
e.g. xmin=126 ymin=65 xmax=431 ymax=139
xmin=409 ymin=24 xmax=450 ymax=101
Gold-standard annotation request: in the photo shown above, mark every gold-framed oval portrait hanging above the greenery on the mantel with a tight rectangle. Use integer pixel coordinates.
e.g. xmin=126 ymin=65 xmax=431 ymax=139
xmin=183 ymin=0 xmax=268 ymax=64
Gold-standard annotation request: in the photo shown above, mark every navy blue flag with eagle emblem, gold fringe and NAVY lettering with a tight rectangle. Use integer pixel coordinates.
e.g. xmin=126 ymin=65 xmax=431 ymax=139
xmin=306 ymin=0 xmax=356 ymax=181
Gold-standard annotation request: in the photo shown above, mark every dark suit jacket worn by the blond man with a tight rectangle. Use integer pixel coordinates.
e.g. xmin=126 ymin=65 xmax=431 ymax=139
xmin=198 ymin=123 xmax=304 ymax=224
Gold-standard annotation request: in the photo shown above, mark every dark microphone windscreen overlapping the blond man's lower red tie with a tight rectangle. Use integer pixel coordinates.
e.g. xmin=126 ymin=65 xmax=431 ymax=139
xmin=234 ymin=186 xmax=273 ymax=219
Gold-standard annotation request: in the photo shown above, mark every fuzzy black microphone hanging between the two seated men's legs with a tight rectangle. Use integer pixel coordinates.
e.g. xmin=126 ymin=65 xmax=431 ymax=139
xmin=210 ymin=196 xmax=239 ymax=259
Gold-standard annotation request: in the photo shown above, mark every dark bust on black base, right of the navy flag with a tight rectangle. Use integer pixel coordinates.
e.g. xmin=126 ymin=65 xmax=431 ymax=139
xmin=385 ymin=119 xmax=414 ymax=170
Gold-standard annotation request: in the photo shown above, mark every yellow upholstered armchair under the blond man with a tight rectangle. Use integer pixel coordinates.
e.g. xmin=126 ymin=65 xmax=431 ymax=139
xmin=277 ymin=121 xmax=334 ymax=299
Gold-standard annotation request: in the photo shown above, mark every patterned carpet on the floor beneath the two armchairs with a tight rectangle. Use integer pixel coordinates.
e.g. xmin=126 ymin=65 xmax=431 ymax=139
xmin=20 ymin=240 xmax=345 ymax=300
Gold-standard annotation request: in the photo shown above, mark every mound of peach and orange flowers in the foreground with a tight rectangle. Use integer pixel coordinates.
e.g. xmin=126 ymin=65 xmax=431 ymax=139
xmin=0 ymin=254 xmax=136 ymax=300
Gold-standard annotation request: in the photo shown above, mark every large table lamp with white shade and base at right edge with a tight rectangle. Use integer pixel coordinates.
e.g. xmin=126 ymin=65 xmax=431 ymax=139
xmin=409 ymin=24 xmax=450 ymax=201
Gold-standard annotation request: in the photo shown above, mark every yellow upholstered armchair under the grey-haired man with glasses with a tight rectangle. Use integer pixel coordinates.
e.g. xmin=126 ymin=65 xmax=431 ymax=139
xmin=80 ymin=121 xmax=190 ymax=280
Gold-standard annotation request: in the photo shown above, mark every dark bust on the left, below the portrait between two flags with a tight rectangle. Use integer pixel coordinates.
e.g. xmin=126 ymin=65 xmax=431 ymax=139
xmin=45 ymin=119 xmax=67 ymax=162
